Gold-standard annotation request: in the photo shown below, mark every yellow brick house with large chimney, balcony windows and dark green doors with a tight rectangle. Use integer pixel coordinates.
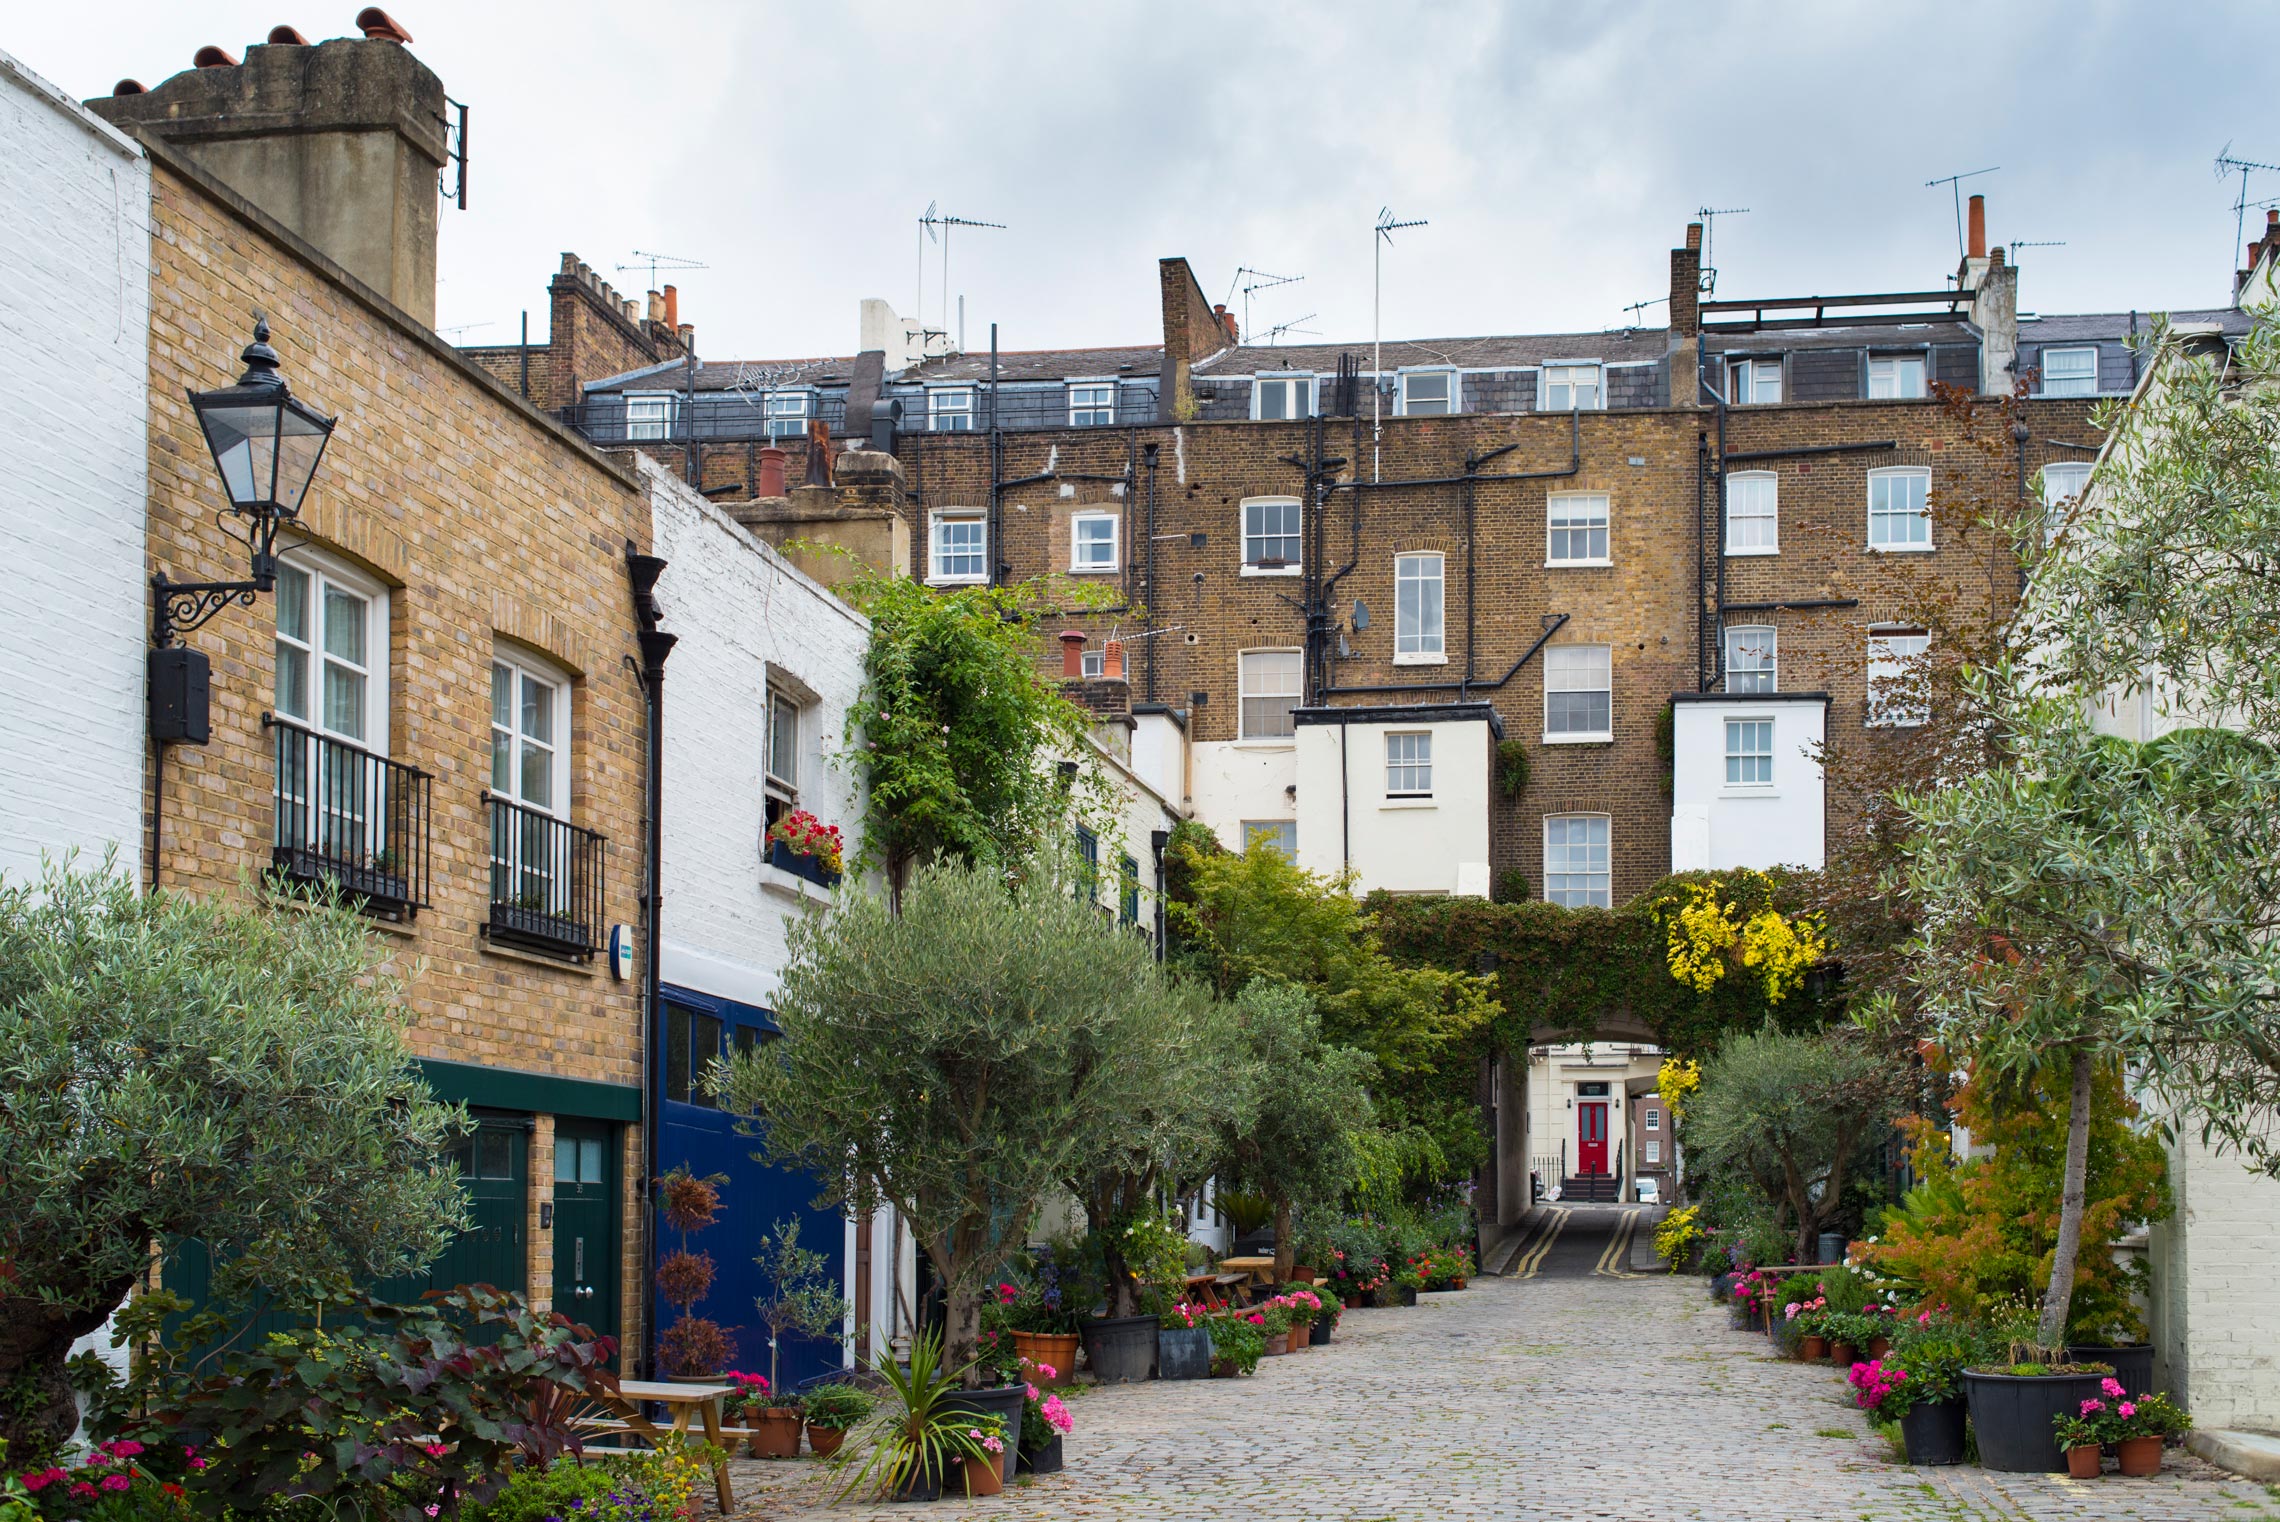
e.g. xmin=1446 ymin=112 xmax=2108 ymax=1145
xmin=89 ymin=26 xmax=650 ymax=1360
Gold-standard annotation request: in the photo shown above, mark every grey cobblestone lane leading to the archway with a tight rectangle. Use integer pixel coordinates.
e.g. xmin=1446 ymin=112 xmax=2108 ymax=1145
xmin=736 ymin=1208 xmax=2280 ymax=1522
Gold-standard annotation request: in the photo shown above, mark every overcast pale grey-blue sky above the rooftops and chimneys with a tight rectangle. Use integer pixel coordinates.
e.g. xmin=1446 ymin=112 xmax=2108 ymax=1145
xmin=17 ymin=0 xmax=2280 ymax=360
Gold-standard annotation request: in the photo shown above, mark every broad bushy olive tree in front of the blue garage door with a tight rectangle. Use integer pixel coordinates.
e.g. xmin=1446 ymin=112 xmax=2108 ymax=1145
xmin=714 ymin=861 xmax=1206 ymax=1367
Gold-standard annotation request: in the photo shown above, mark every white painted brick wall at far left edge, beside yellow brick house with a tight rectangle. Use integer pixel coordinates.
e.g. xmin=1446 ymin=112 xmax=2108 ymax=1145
xmin=0 ymin=52 xmax=149 ymax=879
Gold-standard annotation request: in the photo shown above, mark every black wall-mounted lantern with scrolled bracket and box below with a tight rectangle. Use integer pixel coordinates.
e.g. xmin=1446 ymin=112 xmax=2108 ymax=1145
xmin=150 ymin=317 xmax=335 ymax=745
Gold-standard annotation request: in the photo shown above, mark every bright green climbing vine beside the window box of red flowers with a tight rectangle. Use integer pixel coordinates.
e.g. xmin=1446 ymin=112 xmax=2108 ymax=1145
xmin=841 ymin=576 xmax=1113 ymax=884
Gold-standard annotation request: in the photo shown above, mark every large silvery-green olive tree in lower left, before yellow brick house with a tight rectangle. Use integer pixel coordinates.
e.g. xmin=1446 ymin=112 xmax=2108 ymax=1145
xmin=0 ymin=864 xmax=465 ymax=1454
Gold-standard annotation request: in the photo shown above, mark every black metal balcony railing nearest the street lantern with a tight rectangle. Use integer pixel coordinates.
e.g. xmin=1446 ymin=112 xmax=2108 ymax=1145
xmin=262 ymin=713 xmax=433 ymax=918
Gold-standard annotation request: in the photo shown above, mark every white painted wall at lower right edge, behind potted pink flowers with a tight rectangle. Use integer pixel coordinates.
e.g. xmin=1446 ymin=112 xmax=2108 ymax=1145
xmin=2148 ymin=1135 xmax=2280 ymax=1431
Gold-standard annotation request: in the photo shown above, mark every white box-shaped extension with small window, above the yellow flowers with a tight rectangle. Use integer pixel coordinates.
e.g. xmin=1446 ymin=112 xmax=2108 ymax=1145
xmin=1671 ymin=693 xmax=1829 ymax=873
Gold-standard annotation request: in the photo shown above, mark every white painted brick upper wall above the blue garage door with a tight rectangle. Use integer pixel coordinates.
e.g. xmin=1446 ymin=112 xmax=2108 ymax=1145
xmin=641 ymin=458 xmax=871 ymax=1005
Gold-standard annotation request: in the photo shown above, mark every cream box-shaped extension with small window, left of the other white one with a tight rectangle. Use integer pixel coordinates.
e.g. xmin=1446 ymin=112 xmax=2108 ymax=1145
xmin=1297 ymin=704 xmax=1498 ymax=898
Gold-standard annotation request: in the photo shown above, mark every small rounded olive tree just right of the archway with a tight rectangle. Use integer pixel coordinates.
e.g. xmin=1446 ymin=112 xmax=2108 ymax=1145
xmin=1687 ymin=1028 xmax=1904 ymax=1262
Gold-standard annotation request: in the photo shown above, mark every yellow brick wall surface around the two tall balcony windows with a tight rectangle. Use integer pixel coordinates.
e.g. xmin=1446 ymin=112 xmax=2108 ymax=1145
xmin=150 ymin=157 xmax=650 ymax=1347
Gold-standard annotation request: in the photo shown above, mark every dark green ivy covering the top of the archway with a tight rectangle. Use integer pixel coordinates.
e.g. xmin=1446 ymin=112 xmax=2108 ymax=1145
xmin=1363 ymin=870 xmax=1838 ymax=1057
